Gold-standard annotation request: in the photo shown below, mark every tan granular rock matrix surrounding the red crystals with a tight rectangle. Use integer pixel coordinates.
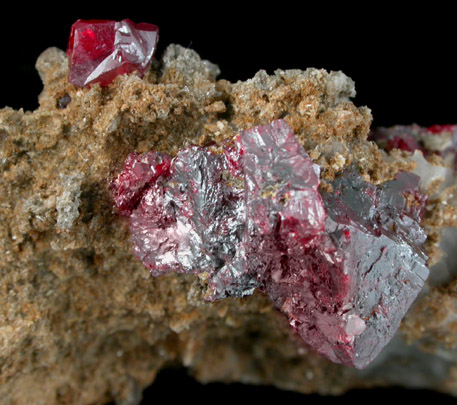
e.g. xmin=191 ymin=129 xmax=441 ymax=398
xmin=0 ymin=45 xmax=457 ymax=404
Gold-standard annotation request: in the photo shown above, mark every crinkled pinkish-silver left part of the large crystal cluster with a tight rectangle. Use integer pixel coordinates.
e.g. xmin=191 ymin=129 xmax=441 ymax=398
xmin=130 ymin=147 xmax=245 ymax=276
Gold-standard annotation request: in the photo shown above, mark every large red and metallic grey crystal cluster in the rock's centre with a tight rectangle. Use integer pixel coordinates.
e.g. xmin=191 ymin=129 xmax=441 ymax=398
xmin=112 ymin=120 xmax=428 ymax=368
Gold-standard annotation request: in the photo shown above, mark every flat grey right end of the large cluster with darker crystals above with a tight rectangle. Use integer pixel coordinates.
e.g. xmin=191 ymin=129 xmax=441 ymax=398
xmin=324 ymin=171 xmax=429 ymax=368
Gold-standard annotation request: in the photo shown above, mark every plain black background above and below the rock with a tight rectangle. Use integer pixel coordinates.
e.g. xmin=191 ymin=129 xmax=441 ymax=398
xmin=0 ymin=1 xmax=457 ymax=403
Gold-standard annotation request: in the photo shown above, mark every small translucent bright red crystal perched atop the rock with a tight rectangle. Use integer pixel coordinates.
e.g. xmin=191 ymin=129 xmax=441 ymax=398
xmin=67 ymin=19 xmax=159 ymax=87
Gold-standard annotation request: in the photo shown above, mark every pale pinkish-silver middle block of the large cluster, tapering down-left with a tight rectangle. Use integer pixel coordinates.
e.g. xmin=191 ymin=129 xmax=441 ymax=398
xmin=211 ymin=120 xmax=326 ymax=299
